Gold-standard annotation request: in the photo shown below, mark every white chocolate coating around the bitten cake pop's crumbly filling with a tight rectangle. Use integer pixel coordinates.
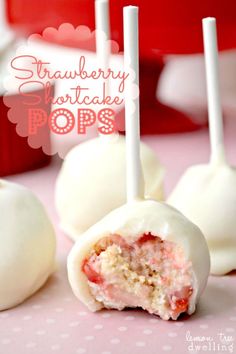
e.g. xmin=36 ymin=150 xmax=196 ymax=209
xmin=67 ymin=200 xmax=210 ymax=314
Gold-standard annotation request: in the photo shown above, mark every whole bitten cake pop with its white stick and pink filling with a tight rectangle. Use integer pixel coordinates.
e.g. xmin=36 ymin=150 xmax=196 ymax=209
xmin=68 ymin=6 xmax=210 ymax=320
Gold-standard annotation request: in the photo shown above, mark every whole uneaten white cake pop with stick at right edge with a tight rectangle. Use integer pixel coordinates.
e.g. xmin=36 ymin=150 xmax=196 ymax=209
xmin=168 ymin=18 xmax=236 ymax=274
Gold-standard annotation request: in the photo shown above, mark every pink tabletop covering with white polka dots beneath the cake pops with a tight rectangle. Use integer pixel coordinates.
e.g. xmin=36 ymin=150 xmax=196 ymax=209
xmin=0 ymin=119 xmax=236 ymax=354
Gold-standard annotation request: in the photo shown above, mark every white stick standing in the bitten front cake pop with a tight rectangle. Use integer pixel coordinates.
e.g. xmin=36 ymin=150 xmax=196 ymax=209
xmin=123 ymin=6 xmax=144 ymax=202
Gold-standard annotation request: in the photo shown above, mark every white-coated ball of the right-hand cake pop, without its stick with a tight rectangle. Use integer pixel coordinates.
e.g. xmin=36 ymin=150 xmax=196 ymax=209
xmin=168 ymin=163 xmax=236 ymax=275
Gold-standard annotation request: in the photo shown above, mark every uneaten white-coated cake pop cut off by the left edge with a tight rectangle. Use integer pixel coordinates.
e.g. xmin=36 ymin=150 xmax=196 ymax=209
xmin=0 ymin=180 xmax=56 ymax=310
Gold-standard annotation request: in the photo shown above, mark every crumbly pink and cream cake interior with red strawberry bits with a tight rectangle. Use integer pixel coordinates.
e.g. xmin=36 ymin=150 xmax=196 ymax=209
xmin=82 ymin=233 xmax=193 ymax=320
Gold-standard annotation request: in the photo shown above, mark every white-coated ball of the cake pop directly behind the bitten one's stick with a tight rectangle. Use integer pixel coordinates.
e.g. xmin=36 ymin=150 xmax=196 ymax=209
xmin=56 ymin=135 xmax=164 ymax=240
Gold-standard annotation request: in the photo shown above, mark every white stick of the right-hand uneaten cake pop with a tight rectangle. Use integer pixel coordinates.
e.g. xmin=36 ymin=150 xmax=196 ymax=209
xmin=202 ymin=17 xmax=225 ymax=163
